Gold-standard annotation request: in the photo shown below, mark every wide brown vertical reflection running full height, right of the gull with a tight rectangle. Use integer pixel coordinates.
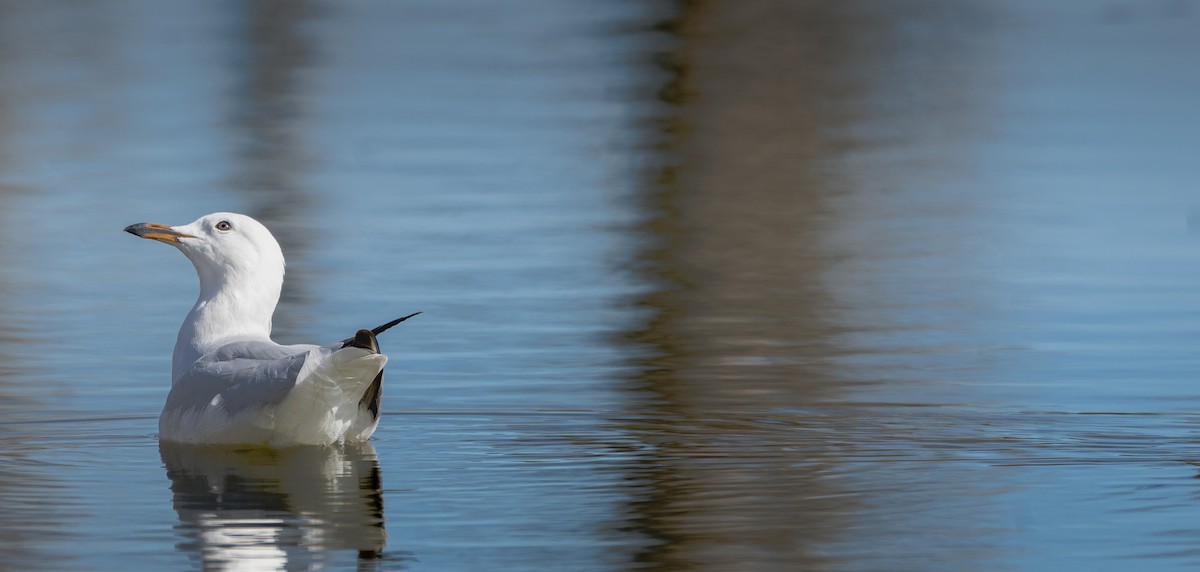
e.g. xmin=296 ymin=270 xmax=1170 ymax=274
xmin=629 ymin=0 xmax=988 ymax=571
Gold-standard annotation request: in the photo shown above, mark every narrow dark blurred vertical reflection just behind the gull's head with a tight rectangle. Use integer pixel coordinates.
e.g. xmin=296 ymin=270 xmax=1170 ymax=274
xmin=229 ymin=0 xmax=317 ymax=339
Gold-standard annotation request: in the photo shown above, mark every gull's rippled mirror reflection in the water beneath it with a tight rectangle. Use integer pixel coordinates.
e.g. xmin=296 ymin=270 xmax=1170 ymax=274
xmin=158 ymin=442 xmax=388 ymax=570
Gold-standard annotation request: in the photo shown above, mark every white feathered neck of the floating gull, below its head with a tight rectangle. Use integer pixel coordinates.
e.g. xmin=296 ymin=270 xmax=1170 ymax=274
xmin=172 ymin=265 xmax=283 ymax=381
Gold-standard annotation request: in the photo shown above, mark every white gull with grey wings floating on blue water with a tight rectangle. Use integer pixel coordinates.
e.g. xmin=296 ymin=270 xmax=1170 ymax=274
xmin=125 ymin=212 xmax=416 ymax=446
